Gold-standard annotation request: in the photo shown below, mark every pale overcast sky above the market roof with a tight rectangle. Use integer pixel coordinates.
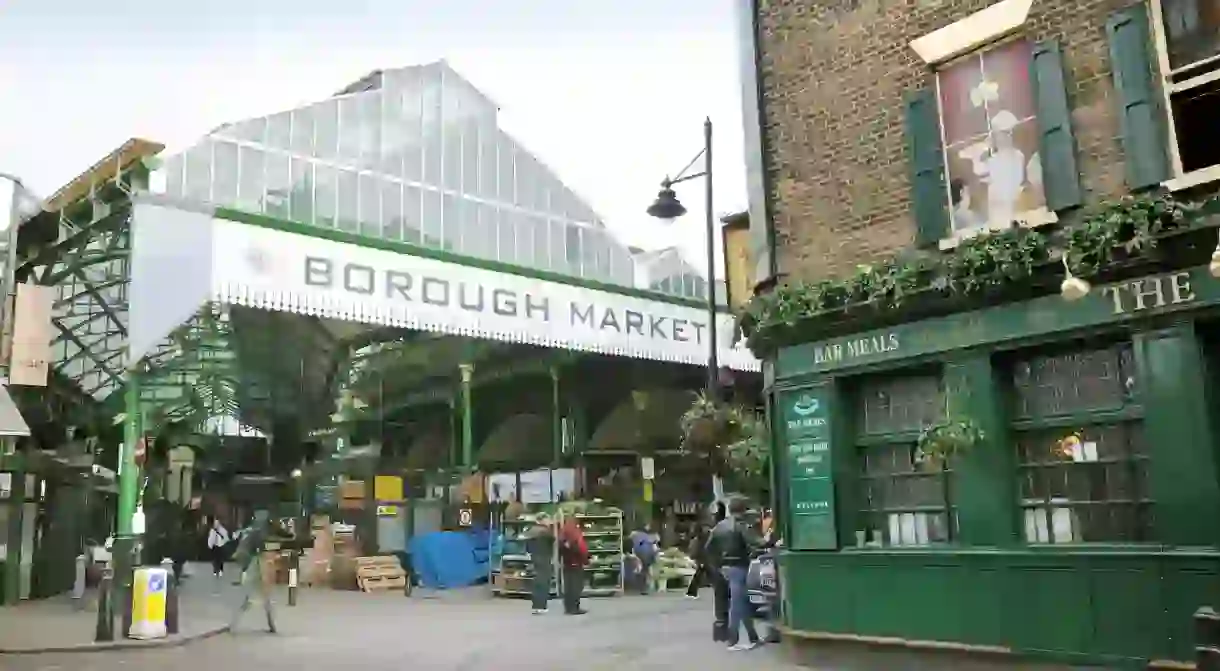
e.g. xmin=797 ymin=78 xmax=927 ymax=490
xmin=0 ymin=0 xmax=745 ymax=268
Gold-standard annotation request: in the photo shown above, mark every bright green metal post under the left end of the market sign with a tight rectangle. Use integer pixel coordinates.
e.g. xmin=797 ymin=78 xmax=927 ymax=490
xmin=111 ymin=368 xmax=143 ymax=636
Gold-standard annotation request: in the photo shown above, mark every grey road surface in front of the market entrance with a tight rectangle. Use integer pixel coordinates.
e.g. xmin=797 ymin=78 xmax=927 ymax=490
xmin=0 ymin=587 xmax=819 ymax=671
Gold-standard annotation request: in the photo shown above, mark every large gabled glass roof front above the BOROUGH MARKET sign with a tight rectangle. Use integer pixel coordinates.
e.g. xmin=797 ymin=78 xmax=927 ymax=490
xmin=154 ymin=61 xmax=705 ymax=301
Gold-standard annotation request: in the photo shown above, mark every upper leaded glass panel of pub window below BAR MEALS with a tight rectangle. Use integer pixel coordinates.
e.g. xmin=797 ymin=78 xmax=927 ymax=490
xmin=858 ymin=376 xmax=944 ymax=434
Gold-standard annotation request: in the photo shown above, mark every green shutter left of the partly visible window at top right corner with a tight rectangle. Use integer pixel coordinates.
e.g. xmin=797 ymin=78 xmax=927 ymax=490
xmin=1105 ymin=2 xmax=1170 ymax=189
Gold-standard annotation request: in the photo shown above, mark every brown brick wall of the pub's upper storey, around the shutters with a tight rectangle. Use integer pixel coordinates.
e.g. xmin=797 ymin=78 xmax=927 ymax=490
xmin=760 ymin=0 xmax=1131 ymax=279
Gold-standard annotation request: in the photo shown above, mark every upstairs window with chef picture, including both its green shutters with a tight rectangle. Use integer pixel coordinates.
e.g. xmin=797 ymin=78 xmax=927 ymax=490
xmin=906 ymin=39 xmax=1083 ymax=246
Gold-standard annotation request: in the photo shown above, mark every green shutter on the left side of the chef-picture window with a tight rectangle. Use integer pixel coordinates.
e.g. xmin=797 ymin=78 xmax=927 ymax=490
xmin=906 ymin=87 xmax=949 ymax=246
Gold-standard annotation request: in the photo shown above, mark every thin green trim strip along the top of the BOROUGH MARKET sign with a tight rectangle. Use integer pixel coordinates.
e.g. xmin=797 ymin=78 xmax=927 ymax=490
xmin=215 ymin=207 xmax=728 ymax=314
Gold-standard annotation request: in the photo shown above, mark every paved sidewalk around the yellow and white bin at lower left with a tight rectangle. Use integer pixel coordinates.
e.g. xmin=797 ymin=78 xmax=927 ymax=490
xmin=0 ymin=564 xmax=239 ymax=653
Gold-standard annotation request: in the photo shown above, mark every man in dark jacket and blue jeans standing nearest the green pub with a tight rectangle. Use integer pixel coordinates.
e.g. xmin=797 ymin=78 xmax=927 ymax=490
xmin=708 ymin=498 xmax=761 ymax=651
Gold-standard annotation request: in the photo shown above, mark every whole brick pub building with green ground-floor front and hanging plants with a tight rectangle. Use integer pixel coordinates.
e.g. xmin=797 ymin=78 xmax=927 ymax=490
xmin=738 ymin=0 xmax=1220 ymax=666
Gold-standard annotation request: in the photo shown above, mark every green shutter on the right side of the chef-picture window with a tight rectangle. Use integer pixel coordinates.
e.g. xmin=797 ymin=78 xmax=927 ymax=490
xmin=1030 ymin=40 xmax=1085 ymax=212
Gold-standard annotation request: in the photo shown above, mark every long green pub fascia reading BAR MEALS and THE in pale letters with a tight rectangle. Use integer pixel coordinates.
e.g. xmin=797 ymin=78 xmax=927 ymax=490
xmin=775 ymin=266 xmax=1220 ymax=381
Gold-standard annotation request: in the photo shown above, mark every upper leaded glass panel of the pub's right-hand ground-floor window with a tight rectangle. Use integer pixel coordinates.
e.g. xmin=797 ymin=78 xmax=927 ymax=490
xmin=1013 ymin=344 xmax=1138 ymax=417
